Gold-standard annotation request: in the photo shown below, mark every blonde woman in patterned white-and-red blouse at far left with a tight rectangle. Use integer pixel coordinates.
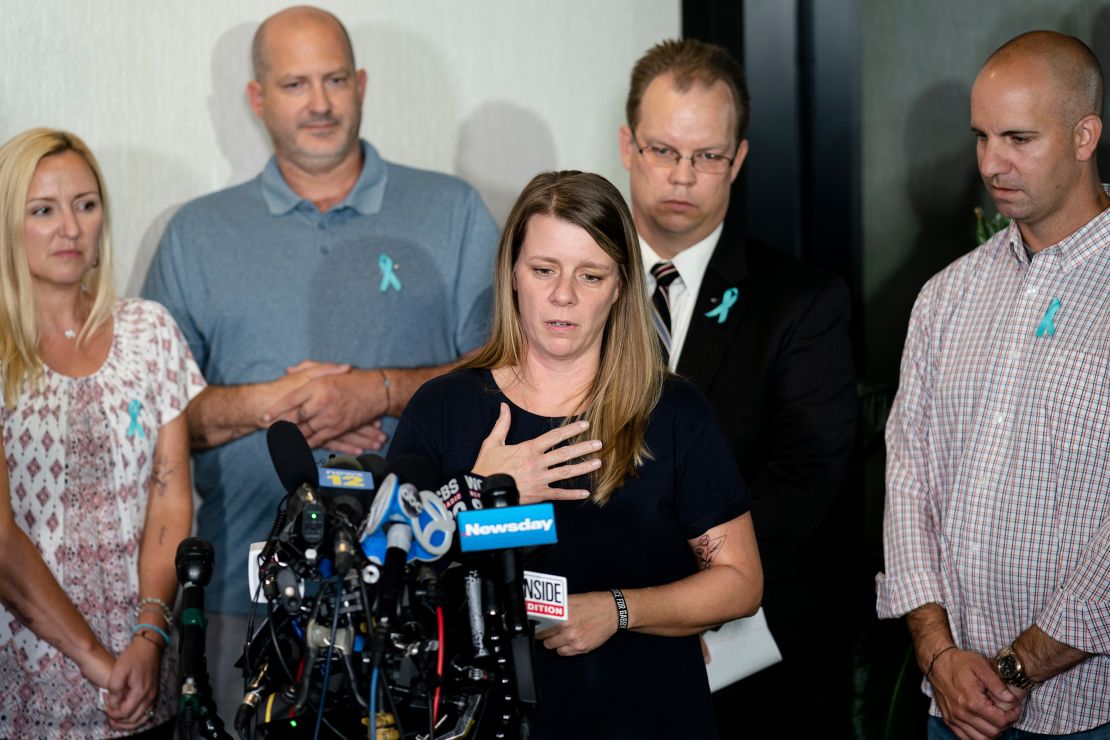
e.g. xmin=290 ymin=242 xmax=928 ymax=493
xmin=0 ymin=129 xmax=203 ymax=738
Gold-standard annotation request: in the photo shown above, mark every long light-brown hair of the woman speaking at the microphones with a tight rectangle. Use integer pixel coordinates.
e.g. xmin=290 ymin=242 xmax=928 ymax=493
xmin=465 ymin=171 xmax=667 ymax=505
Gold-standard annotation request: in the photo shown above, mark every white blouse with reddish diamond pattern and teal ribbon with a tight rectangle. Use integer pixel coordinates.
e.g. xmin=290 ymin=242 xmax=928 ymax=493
xmin=0 ymin=298 xmax=204 ymax=738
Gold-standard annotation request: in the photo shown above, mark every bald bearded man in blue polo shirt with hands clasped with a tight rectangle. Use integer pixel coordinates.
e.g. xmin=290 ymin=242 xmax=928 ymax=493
xmin=143 ymin=2 xmax=497 ymax=718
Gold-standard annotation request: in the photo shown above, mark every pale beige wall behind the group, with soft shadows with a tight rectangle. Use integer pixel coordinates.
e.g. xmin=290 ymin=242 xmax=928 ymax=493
xmin=0 ymin=0 xmax=680 ymax=294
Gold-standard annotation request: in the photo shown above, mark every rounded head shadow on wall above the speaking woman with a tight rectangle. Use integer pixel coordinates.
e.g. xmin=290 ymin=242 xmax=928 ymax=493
xmin=455 ymin=101 xmax=558 ymax=226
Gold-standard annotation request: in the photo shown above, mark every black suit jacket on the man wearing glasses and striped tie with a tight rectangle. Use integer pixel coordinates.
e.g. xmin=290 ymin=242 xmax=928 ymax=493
xmin=678 ymin=223 xmax=856 ymax=652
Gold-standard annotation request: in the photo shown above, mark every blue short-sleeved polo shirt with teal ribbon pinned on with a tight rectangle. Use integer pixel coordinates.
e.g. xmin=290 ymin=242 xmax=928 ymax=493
xmin=142 ymin=142 xmax=498 ymax=614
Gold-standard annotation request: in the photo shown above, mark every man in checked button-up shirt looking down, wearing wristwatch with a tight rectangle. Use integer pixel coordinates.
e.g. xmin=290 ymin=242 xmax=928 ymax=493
xmin=877 ymin=31 xmax=1110 ymax=740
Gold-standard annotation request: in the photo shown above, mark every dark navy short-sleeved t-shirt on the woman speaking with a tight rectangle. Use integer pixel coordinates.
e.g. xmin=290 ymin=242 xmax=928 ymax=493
xmin=390 ymin=369 xmax=750 ymax=740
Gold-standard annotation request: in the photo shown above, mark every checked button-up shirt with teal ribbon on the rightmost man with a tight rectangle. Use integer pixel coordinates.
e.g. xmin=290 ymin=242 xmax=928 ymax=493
xmin=876 ymin=210 xmax=1110 ymax=733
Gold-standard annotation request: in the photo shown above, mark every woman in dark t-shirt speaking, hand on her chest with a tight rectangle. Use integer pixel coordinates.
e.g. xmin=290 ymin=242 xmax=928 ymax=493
xmin=390 ymin=172 xmax=763 ymax=739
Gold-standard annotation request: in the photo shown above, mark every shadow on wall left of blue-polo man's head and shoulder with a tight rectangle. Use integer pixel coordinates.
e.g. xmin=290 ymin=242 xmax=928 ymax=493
xmin=127 ymin=23 xmax=270 ymax=295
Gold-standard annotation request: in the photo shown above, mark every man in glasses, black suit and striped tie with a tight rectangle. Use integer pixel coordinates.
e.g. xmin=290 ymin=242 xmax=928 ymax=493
xmin=620 ymin=40 xmax=856 ymax=738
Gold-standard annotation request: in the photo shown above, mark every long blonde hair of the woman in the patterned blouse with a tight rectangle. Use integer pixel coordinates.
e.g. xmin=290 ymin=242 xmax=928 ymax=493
xmin=0 ymin=129 xmax=115 ymax=409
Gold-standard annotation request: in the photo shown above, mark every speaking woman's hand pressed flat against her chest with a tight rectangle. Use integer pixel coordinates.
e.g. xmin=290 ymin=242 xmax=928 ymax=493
xmin=474 ymin=403 xmax=602 ymax=505
